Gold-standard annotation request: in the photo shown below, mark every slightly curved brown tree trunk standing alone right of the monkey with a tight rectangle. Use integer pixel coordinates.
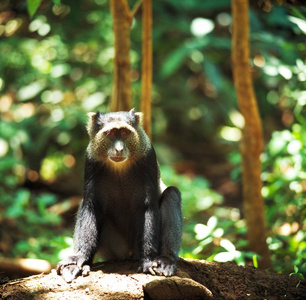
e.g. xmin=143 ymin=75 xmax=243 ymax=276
xmin=232 ymin=0 xmax=271 ymax=268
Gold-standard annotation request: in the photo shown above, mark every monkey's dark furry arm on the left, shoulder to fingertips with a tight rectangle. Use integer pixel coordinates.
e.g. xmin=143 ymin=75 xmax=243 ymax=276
xmin=57 ymin=158 xmax=103 ymax=282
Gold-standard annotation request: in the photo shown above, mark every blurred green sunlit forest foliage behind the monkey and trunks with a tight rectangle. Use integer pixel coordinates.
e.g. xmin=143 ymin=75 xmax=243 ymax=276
xmin=0 ymin=0 xmax=306 ymax=276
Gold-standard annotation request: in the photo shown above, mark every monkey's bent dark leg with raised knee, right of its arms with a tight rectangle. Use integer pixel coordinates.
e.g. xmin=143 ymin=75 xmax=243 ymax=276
xmin=152 ymin=187 xmax=183 ymax=276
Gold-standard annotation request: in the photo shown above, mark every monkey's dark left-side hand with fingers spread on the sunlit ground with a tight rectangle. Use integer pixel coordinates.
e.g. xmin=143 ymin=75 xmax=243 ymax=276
xmin=56 ymin=255 xmax=90 ymax=283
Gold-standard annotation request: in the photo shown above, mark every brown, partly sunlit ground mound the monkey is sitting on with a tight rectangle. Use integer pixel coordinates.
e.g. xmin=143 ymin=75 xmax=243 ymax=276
xmin=0 ymin=259 xmax=306 ymax=300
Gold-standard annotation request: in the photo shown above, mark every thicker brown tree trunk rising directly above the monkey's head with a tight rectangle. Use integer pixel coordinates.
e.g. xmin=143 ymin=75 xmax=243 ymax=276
xmin=110 ymin=0 xmax=132 ymax=111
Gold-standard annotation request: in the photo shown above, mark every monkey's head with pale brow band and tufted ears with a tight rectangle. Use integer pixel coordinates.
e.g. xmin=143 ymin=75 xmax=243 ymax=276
xmin=87 ymin=109 xmax=150 ymax=170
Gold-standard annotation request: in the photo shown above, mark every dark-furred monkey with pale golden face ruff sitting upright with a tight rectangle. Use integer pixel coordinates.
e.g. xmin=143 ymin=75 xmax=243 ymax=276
xmin=57 ymin=109 xmax=183 ymax=283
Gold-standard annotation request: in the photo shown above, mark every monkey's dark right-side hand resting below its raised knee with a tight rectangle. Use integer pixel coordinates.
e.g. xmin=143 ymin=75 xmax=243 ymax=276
xmin=138 ymin=256 xmax=177 ymax=276
